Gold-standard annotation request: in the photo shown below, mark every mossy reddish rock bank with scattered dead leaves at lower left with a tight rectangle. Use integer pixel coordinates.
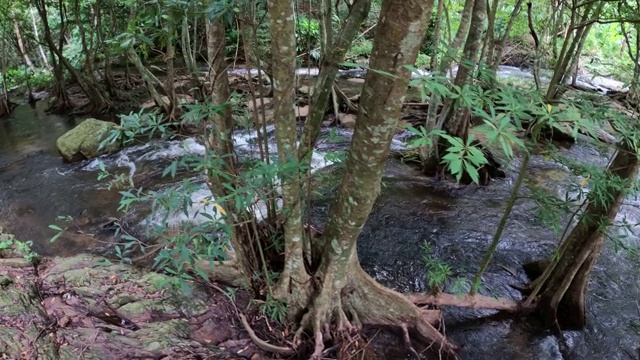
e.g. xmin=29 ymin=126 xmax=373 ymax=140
xmin=0 ymin=228 xmax=280 ymax=360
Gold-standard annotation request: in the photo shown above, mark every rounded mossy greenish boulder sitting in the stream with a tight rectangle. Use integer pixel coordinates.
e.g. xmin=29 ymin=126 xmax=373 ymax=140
xmin=56 ymin=119 xmax=120 ymax=162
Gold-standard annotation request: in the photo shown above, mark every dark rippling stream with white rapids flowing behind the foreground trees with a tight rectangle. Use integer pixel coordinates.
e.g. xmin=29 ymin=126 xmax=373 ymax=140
xmin=0 ymin=69 xmax=640 ymax=360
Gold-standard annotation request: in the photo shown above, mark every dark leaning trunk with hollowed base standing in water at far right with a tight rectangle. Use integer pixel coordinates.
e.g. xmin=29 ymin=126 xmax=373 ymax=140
xmin=524 ymin=141 xmax=638 ymax=328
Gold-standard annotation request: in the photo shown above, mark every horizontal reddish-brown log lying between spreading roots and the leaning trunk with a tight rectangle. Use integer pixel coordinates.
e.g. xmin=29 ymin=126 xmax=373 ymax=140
xmin=406 ymin=293 xmax=524 ymax=313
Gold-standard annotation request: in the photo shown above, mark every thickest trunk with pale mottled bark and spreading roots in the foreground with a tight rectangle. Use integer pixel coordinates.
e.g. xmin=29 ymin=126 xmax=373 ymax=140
xmin=282 ymin=0 xmax=455 ymax=359
